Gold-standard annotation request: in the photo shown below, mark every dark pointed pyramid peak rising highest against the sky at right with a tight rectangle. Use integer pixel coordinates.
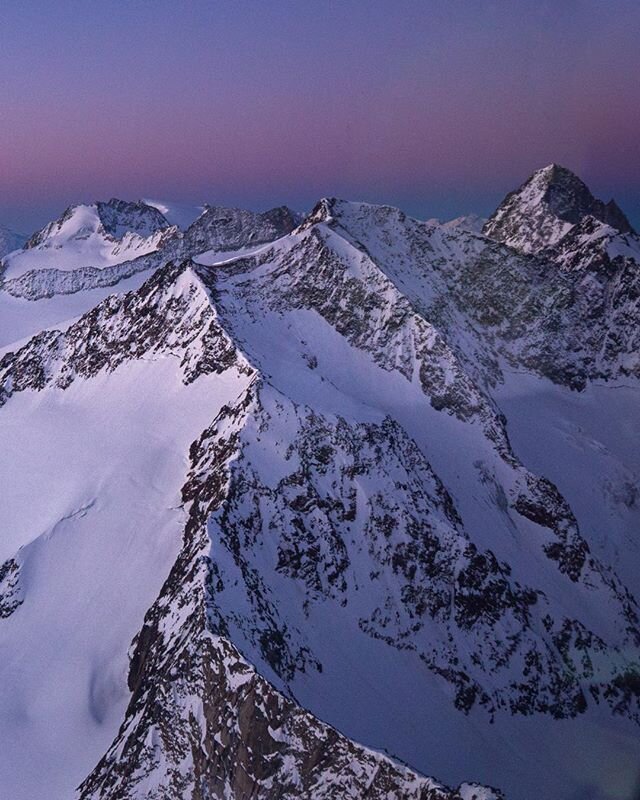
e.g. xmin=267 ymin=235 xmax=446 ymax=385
xmin=483 ymin=164 xmax=633 ymax=253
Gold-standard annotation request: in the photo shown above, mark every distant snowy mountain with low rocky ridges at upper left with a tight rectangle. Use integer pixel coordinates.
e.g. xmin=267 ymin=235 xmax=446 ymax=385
xmin=0 ymin=200 xmax=301 ymax=347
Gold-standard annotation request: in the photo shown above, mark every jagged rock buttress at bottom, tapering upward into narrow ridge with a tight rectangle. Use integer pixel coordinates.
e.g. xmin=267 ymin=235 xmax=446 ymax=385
xmin=80 ymin=384 xmax=499 ymax=800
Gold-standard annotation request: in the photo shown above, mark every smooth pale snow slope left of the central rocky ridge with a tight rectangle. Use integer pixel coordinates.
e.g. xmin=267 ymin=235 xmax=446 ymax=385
xmin=0 ymin=268 xmax=255 ymax=800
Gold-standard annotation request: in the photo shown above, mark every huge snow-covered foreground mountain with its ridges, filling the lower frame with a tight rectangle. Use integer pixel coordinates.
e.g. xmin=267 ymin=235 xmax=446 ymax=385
xmin=0 ymin=166 xmax=640 ymax=800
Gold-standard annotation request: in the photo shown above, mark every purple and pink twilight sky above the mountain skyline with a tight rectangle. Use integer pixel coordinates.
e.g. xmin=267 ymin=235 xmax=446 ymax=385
xmin=0 ymin=0 xmax=640 ymax=233
